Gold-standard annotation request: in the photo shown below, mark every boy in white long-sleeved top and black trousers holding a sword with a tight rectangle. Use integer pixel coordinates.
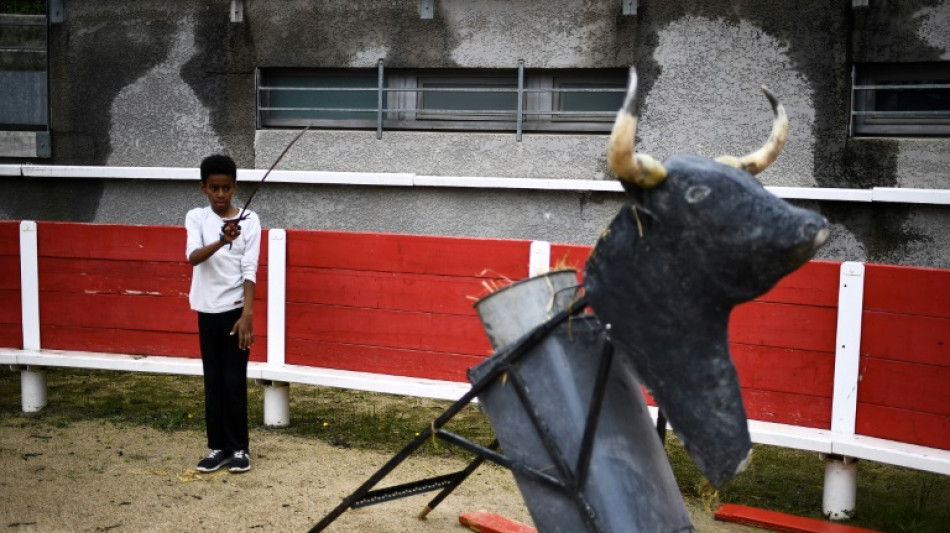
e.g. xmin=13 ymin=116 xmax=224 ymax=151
xmin=185 ymin=155 xmax=261 ymax=472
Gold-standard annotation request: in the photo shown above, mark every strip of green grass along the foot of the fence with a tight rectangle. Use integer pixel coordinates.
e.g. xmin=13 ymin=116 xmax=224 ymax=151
xmin=0 ymin=369 xmax=950 ymax=533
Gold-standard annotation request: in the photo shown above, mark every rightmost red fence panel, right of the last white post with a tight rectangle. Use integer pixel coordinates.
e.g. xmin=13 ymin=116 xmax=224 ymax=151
xmin=856 ymin=264 xmax=950 ymax=450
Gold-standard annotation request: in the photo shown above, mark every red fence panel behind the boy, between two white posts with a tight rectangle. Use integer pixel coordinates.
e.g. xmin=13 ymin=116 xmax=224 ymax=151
xmin=38 ymin=222 xmax=267 ymax=361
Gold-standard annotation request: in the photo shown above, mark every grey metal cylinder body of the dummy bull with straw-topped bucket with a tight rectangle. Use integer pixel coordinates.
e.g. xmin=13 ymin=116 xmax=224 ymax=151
xmin=469 ymin=271 xmax=692 ymax=533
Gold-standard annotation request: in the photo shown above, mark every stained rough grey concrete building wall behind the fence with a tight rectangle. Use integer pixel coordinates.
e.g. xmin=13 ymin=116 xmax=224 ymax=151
xmin=0 ymin=0 xmax=950 ymax=267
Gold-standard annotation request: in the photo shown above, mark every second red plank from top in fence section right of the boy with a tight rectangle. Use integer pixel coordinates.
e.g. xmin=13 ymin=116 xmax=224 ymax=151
xmin=287 ymin=267 xmax=487 ymax=315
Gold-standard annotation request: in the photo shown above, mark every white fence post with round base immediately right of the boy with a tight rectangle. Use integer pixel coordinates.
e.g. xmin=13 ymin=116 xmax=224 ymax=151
xmin=262 ymin=229 xmax=290 ymax=427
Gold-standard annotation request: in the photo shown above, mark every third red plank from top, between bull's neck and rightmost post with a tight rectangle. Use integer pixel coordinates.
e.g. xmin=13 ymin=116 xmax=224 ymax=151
xmin=729 ymin=343 xmax=835 ymax=398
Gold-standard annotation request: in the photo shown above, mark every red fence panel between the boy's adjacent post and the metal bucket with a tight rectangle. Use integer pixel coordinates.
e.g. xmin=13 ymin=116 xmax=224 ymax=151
xmin=286 ymin=230 xmax=530 ymax=381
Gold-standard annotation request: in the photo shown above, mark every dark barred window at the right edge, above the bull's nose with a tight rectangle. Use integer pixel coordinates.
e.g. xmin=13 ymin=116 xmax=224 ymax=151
xmin=851 ymin=63 xmax=950 ymax=136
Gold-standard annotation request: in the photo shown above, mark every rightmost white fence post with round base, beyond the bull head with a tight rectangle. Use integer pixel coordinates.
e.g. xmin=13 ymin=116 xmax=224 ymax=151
xmin=822 ymin=261 xmax=864 ymax=520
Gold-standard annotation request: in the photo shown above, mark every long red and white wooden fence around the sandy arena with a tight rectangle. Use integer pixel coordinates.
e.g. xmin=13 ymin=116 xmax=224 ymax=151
xmin=0 ymin=221 xmax=950 ymax=516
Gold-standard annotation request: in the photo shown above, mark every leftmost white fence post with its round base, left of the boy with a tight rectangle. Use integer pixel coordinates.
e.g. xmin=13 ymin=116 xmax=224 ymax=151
xmin=20 ymin=220 xmax=46 ymax=413
